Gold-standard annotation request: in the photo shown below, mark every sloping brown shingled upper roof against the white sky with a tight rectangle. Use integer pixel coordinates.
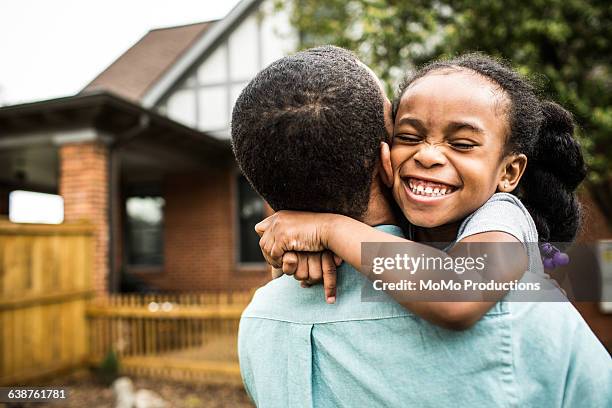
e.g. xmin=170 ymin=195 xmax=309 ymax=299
xmin=81 ymin=21 xmax=215 ymax=101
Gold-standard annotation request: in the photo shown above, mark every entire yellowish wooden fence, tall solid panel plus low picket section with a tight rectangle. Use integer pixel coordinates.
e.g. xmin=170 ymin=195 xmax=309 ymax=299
xmin=0 ymin=220 xmax=252 ymax=386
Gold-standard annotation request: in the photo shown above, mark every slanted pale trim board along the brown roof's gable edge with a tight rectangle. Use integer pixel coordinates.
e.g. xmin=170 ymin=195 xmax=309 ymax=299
xmin=141 ymin=0 xmax=262 ymax=108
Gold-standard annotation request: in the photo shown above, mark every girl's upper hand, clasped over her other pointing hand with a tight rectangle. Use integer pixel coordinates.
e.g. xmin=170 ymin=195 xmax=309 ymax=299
xmin=255 ymin=211 xmax=338 ymax=268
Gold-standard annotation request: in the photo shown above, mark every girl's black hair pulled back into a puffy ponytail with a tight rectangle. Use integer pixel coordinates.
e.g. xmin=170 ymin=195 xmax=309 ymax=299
xmin=393 ymin=53 xmax=587 ymax=242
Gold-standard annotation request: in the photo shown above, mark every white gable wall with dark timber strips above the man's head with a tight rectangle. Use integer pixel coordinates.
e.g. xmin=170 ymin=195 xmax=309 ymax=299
xmin=154 ymin=0 xmax=297 ymax=139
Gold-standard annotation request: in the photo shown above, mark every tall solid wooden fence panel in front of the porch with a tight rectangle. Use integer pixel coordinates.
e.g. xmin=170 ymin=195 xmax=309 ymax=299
xmin=0 ymin=221 xmax=93 ymax=385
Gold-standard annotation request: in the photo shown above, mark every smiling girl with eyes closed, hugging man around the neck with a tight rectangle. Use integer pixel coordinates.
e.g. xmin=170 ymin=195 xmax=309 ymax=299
xmin=256 ymin=54 xmax=586 ymax=328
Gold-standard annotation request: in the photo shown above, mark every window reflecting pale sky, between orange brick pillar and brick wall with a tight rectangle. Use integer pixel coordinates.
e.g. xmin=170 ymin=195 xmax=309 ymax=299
xmin=125 ymin=196 xmax=164 ymax=266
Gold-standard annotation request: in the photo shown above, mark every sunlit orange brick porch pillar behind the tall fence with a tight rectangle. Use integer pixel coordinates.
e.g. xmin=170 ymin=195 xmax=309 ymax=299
xmin=59 ymin=141 xmax=109 ymax=294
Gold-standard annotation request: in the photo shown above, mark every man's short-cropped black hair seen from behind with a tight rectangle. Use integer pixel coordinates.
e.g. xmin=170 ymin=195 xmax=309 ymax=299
xmin=231 ymin=46 xmax=387 ymax=218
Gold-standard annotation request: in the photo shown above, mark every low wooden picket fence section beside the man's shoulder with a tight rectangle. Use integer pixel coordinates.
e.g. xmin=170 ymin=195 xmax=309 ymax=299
xmin=87 ymin=291 xmax=252 ymax=383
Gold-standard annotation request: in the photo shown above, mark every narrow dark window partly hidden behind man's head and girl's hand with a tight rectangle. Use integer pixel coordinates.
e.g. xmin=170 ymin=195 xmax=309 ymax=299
xmin=237 ymin=175 xmax=265 ymax=264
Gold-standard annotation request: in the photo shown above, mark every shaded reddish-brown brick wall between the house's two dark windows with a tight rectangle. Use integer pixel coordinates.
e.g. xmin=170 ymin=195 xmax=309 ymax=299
xmin=132 ymin=168 xmax=269 ymax=291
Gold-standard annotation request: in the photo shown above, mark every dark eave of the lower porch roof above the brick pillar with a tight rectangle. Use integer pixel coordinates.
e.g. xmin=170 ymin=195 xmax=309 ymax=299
xmin=0 ymin=92 xmax=232 ymax=163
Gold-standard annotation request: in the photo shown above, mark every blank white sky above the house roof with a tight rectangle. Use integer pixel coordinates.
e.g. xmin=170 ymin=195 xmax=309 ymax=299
xmin=0 ymin=0 xmax=238 ymax=105
